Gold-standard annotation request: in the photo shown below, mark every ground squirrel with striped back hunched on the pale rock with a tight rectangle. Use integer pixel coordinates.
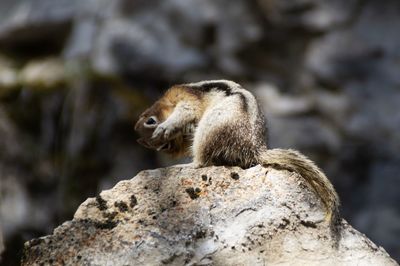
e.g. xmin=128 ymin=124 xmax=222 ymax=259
xmin=135 ymin=80 xmax=339 ymax=225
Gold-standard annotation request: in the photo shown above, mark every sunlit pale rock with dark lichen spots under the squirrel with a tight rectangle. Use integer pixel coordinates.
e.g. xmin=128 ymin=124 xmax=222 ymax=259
xmin=22 ymin=165 xmax=396 ymax=265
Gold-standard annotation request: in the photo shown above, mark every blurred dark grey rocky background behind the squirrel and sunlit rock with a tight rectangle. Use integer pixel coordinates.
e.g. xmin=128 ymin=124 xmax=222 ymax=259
xmin=0 ymin=0 xmax=400 ymax=265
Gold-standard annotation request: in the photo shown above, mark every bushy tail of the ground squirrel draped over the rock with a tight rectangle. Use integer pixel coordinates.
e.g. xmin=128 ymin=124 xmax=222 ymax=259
xmin=260 ymin=149 xmax=339 ymax=227
